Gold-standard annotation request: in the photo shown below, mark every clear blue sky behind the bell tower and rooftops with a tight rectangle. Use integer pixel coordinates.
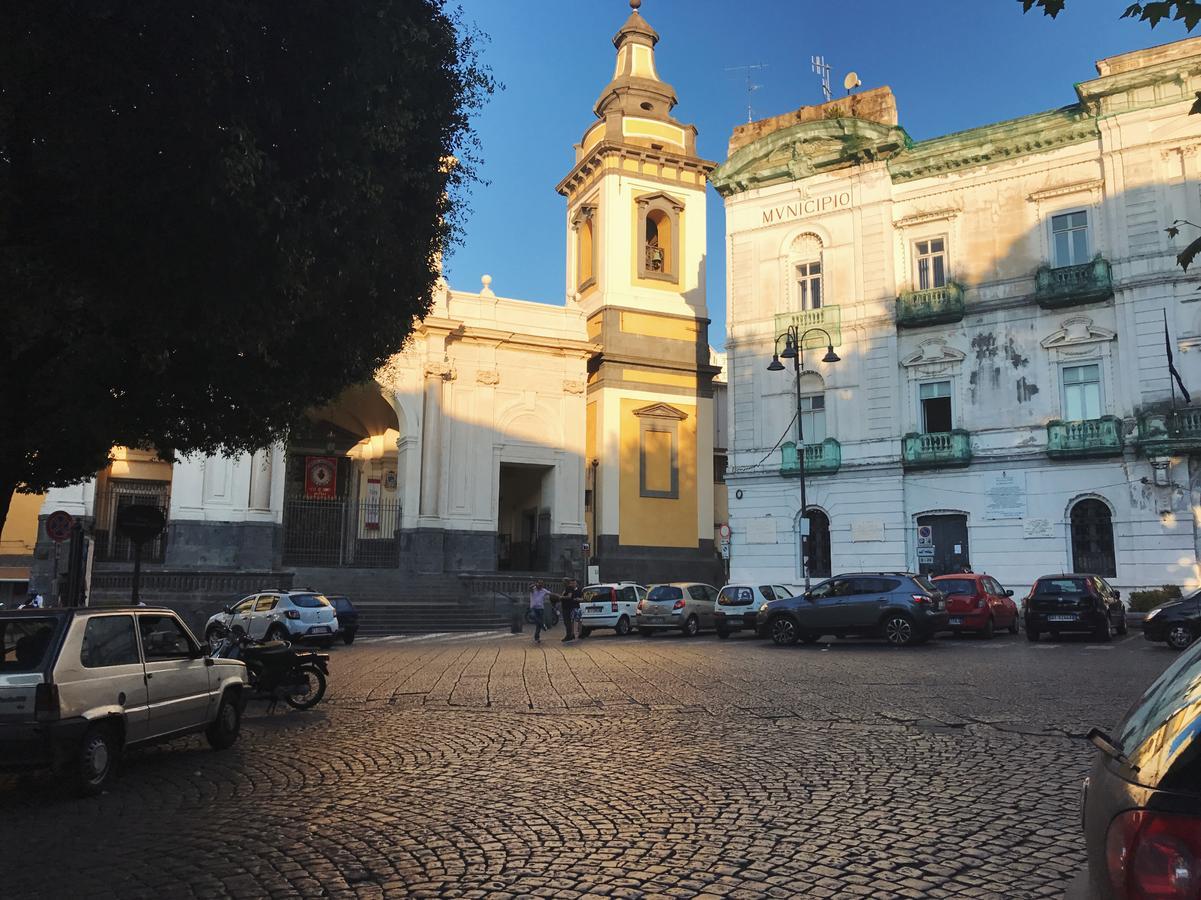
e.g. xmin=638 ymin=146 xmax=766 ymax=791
xmin=447 ymin=0 xmax=1188 ymax=347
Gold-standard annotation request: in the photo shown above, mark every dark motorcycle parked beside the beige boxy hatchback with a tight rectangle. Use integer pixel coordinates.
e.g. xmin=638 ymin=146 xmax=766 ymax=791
xmin=213 ymin=628 xmax=329 ymax=711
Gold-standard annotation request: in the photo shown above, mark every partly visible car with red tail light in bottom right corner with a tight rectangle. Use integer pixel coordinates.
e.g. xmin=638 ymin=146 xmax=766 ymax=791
xmin=1082 ymin=644 xmax=1201 ymax=899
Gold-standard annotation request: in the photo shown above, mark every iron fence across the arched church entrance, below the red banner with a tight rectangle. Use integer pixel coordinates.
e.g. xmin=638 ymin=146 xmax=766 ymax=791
xmin=283 ymin=500 xmax=401 ymax=568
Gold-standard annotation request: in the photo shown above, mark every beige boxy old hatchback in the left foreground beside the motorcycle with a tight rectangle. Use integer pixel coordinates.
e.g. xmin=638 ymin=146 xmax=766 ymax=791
xmin=0 ymin=607 xmax=246 ymax=794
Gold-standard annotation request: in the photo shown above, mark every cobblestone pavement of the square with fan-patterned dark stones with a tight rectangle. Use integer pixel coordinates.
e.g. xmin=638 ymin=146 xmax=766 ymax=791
xmin=0 ymin=633 xmax=1173 ymax=900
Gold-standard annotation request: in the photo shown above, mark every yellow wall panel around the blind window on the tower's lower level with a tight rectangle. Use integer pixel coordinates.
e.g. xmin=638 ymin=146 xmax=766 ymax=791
xmin=619 ymin=400 xmax=696 ymax=548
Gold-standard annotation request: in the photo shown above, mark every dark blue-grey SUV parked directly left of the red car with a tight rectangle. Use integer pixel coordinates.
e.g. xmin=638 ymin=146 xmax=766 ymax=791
xmin=755 ymin=572 xmax=949 ymax=646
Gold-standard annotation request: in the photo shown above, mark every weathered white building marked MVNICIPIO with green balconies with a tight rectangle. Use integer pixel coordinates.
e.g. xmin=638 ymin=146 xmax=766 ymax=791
xmin=712 ymin=38 xmax=1201 ymax=589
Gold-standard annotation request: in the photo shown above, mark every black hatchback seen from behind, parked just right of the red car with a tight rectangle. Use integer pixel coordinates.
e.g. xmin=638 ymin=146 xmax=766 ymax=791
xmin=1024 ymin=574 xmax=1127 ymax=640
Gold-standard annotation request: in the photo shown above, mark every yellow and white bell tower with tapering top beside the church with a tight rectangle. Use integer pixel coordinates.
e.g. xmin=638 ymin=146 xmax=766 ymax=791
xmin=557 ymin=0 xmax=721 ymax=583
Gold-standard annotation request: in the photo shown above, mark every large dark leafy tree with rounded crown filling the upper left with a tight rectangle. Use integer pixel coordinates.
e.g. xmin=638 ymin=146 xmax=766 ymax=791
xmin=0 ymin=0 xmax=494 ymax=531
